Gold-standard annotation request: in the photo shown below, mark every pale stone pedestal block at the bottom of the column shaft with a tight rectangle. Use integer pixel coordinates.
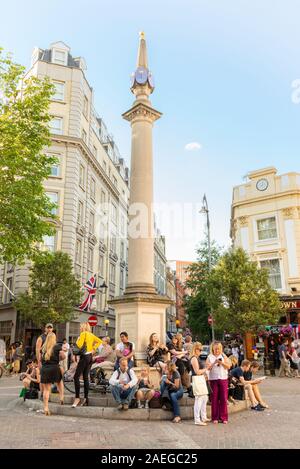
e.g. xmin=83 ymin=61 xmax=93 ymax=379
xmin=109 ymin=292 xmax=173 ymax=366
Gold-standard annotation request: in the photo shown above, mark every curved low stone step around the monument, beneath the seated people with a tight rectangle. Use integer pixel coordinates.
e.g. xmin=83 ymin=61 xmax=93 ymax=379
xmin=24 ymin=399 xmax=249 ymax=421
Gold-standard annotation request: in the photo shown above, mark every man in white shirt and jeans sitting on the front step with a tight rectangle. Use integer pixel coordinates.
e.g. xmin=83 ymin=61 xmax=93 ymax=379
xmin=109 ymin=358 xmax=138 ymax=410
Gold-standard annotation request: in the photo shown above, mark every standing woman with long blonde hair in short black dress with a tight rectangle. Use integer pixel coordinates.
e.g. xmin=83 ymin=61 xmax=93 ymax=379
xmin=41 ymin=332 xmax=65 ymax=415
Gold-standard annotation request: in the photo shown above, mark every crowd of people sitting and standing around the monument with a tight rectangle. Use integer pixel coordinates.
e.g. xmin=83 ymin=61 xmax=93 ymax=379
xmin=0 ymin=323 xmax=300 ymax=426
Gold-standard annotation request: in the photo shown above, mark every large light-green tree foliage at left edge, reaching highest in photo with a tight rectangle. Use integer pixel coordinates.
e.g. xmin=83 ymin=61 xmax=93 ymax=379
xmin=0 ymin=49 xmax=56 ymax=263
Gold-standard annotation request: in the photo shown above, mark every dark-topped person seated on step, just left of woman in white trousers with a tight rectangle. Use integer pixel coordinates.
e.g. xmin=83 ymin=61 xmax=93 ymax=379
xmin=160 ymin=361 xmax=183 ymax=423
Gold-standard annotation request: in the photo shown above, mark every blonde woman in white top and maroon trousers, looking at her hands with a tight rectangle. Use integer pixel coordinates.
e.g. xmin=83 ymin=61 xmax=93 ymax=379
xmin=206 ymin=342 xmax=231 ymax=424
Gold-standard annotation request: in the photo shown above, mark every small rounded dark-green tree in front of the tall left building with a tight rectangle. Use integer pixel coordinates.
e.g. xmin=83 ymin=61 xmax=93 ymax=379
xmin=15 ymin=251 xmax=81 ymax=326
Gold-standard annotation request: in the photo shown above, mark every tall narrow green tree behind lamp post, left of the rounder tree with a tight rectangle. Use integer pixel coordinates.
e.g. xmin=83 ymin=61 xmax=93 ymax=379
xmin=185 ymin=241 xmax=221 ymax=342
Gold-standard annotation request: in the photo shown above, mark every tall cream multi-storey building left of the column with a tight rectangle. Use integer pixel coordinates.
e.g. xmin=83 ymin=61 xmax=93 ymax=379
xmin=0 ymin=42 xmax=129 ymax=341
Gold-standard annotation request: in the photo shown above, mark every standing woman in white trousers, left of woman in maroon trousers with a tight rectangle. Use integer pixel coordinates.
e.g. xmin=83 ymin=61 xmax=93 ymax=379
xmin=191 ymin=342 xmax=210 ymax=426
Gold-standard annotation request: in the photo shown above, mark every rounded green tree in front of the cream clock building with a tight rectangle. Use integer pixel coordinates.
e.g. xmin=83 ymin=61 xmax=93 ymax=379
xmin=206 ymin=248 xmax=280 ymax=334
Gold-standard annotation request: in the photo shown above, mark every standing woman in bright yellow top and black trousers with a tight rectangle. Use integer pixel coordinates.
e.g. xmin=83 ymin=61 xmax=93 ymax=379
xmin=72 ymin=322 xmax=102 ymax=407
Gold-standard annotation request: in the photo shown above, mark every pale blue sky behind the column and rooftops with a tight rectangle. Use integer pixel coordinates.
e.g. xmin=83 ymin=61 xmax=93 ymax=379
xmin=0 ymin=0 xmax=300 ymax=260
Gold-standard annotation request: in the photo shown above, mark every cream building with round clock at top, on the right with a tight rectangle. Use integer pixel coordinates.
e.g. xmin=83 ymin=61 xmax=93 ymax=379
xmin=231 ymin=167 xmax=300 ymax=323
